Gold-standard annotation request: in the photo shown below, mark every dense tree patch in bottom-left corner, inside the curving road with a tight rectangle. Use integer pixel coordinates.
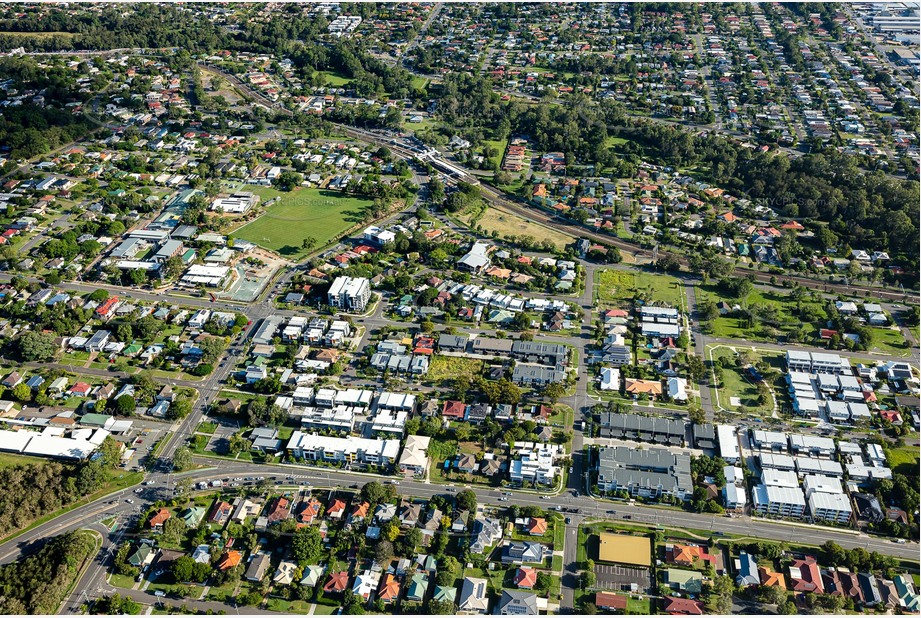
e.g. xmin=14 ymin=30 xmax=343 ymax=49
xmin=0 ymin=528 xmax=93 ymax=615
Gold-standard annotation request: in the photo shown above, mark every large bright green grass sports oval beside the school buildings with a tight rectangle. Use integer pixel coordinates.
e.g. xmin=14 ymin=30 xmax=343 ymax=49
xmin=233 ymin=187 xmax=371 ymax=259
